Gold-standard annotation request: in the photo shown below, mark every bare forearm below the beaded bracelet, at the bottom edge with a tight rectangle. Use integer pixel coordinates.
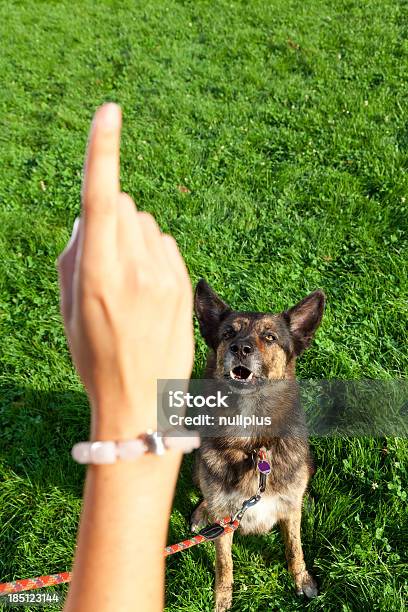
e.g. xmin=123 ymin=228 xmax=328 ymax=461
xmin=64 ymin=451 xmax=181 ymax=612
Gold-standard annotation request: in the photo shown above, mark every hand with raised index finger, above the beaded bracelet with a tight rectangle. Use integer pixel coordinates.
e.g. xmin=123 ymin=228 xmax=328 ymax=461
xmin=58 ymin=104 xmax=194 ymax=439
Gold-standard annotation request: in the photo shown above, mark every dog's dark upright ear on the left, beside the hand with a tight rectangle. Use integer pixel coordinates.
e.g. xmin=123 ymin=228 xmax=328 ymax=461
xmin=194 ymin=278 xmax=231 ymax=348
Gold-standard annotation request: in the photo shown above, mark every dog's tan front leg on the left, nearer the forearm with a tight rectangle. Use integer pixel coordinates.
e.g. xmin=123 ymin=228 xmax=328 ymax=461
xmin=215 ymin=533 xmax=234 ymax=612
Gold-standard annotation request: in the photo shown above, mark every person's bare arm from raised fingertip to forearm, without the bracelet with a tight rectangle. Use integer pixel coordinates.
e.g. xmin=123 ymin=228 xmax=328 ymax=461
xmin=58 ymin=104 xmax=194 ymax=612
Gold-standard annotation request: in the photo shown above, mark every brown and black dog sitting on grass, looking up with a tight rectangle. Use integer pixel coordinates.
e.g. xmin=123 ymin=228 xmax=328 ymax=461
xmin=192 ymin=280 xmax=325 ymax=612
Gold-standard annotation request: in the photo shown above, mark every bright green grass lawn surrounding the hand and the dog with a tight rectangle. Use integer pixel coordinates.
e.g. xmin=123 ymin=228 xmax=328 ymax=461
xmin=0 ymin=0 xmax=408 ymax=612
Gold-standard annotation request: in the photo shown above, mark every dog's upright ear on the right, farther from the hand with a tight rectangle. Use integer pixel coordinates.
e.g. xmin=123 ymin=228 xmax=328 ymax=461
xmin=283 ymin=290 xmax=326 ymax=355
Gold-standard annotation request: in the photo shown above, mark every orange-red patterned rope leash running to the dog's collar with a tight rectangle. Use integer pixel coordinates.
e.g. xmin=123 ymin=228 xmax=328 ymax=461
xmin=0 ymin=447 xmax=271 ymax=596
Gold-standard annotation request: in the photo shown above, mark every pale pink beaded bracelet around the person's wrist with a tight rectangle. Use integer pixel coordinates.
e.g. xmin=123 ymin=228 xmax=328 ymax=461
xmin=71 ymin=431 xmax=200 ymax=465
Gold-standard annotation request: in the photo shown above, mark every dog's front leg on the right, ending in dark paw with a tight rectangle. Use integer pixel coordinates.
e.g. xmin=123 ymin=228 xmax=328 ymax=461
xmin=281 ymin=508 xmax=318 ymax=598
